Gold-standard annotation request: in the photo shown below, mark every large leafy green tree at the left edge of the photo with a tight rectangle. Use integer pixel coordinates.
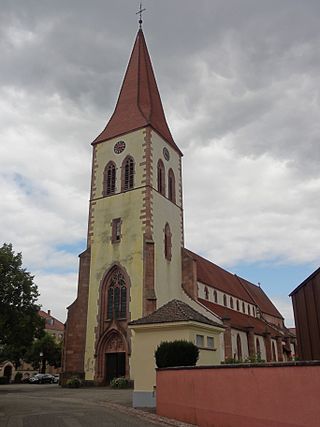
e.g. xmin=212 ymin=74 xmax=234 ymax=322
xmin=0 ymin=243 xmax=44 ymax=367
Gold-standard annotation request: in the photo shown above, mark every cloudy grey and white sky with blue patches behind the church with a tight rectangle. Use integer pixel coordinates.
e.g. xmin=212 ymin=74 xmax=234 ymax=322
xmin=0 ymin=0 xmax=320 ymax=326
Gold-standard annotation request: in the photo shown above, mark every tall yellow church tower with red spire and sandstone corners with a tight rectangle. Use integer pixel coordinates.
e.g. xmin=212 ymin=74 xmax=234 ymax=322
xmin=63 ymin=29 xmax=183 ymax=383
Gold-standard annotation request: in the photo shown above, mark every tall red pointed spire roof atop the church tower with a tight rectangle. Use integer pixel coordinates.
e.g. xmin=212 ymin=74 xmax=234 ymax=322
xmin=93 ymin=29 xmax=180 ymax=153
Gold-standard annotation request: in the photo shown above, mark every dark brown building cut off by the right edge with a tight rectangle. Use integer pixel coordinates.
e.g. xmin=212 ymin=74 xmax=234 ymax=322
xmin=290 ymin=268 xmax=320 ymax=360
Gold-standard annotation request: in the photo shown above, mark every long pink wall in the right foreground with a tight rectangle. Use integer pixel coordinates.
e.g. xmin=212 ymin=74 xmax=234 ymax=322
xmin=157 ymin=364 xmax=320 ymax=427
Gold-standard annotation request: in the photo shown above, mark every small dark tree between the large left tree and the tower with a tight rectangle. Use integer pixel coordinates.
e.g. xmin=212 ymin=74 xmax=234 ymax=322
xmin=25 ymin=332 xmax=61 ymax=374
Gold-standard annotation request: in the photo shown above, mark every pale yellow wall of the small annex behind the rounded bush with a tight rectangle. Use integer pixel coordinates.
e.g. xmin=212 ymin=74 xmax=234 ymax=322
xmin=130 ymin=322 xmax=220 ymax=391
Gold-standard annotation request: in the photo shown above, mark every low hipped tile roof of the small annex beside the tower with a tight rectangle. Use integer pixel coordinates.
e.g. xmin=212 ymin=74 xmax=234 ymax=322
xmin=129 ymin=299 xmax=223 ymax=328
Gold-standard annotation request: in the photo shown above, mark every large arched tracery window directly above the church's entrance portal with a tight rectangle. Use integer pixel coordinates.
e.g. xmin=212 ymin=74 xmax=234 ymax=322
xmin=107 ymin=269 xmax=127 ymax=319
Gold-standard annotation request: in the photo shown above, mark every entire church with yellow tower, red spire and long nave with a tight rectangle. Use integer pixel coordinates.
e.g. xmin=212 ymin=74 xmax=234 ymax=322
xmin=62 ymin=28 xmax=295 ymax=404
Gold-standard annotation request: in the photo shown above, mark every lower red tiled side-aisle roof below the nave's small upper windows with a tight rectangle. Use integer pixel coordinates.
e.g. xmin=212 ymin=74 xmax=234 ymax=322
xmin=199 ymin=298 xmax=279 ymax=337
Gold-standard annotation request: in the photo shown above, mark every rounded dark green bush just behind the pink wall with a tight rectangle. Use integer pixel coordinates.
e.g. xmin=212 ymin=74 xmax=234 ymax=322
xmin=154 ymin=340 xmax=199 ymax=368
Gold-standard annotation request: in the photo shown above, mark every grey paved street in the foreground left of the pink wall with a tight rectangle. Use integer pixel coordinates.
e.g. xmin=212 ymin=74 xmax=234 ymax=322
xmin=0 ymin=384 xmax=192 ymax=427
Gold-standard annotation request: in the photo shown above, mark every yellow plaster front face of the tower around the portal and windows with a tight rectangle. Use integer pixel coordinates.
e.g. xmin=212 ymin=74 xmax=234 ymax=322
xmin=85 ymin=130 xmax=144 ymax=380
